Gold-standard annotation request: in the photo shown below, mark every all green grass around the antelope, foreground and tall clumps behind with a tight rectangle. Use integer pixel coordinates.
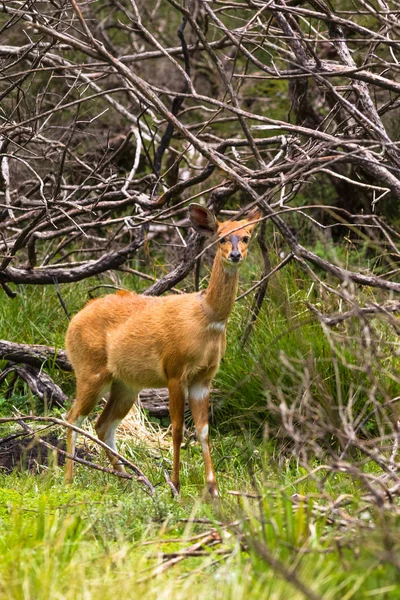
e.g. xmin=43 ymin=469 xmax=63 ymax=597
xmin=0 ymin=255 xmax=400 ymax=600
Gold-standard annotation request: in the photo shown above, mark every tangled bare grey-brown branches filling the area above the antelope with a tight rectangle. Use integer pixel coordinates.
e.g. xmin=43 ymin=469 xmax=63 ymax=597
xmin=0 ymin=0 xmax=400 ymax=295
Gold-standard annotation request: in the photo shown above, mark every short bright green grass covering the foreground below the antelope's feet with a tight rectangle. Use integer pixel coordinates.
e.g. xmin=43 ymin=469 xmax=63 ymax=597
xmin=0 ymin=450 xmax=400 ymax=600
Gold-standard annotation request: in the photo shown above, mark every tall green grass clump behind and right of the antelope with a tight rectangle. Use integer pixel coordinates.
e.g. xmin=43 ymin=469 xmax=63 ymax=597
xmin=215 ymin=252 xmax=398 ymax=446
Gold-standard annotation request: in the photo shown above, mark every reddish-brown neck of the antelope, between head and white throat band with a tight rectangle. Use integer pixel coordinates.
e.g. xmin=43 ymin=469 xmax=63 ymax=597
xmin=202 ymin=253 xmax=239 ymax=323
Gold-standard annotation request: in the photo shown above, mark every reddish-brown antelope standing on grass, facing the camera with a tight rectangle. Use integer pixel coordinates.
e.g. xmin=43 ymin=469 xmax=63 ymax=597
xmin=66 ymin=204 xmax=260 ymax=496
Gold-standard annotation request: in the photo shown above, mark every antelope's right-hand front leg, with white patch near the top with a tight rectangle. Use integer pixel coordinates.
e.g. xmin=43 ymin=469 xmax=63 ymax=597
xmin=189 ymin=382 xmax=219 ymax=498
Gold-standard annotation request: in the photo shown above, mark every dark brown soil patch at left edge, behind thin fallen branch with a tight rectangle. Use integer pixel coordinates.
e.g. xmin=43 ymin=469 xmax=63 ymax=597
xmin=0 ymin=433 xmax=91 ymax=473
